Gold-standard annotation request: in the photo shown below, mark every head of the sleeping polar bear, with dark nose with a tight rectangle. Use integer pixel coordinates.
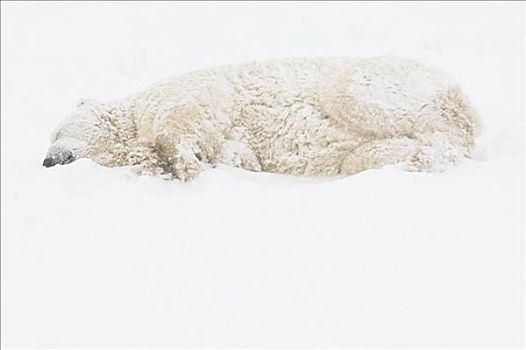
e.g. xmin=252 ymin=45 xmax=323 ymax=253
xmin=43 ymin=100 xmax=132 ymax=167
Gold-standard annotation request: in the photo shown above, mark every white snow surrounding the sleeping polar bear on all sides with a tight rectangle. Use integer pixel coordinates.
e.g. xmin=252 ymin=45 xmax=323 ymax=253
xmin=1 ymin=2 xmax=525 ymax=347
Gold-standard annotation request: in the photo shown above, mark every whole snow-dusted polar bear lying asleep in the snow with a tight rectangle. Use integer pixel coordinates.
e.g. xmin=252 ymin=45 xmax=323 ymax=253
xmin=43 ymin=57 xmax=479 ymax=181
